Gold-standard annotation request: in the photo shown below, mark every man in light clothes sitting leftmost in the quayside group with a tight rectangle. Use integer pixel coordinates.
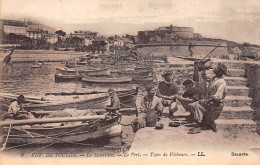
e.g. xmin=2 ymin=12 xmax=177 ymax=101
xmin=135 ymin=85 xmax=163 ymax=127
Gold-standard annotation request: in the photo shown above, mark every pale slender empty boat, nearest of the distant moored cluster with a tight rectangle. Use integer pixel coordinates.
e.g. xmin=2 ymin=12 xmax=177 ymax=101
xmin=82 ymin=76 xmax=132 ymax=83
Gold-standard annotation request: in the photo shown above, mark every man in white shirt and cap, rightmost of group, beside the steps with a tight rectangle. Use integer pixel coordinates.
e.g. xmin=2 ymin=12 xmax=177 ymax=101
xmin=189 ymin=63 xmax=227 ymax=134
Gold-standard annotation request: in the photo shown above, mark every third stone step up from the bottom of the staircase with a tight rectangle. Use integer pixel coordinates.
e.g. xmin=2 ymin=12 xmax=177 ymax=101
xmin=224 ymin=96 xmax=252 ymax=107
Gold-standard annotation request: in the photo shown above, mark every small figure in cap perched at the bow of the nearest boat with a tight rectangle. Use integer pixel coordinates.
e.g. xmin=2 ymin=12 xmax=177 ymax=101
xmin=106 ymin=88 xmax=120 ymax=114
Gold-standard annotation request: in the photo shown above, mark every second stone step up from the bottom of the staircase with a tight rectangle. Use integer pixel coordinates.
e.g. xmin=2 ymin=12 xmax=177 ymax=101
xmin=219 ymin=106 xmax=254 ymax=120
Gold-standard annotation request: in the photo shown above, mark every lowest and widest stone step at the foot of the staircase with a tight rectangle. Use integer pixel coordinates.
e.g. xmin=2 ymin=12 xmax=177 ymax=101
xmin=215 ymin=119 xmax=257 ymax=134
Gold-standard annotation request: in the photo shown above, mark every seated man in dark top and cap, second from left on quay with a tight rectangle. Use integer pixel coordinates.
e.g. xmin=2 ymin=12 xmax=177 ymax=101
xmin=156 ymin=71 xmax=179 ymax=118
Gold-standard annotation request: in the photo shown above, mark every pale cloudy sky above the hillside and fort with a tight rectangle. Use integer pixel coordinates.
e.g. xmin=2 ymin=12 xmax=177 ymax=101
xmin=0 ymin=0 xmax=260 ymax=45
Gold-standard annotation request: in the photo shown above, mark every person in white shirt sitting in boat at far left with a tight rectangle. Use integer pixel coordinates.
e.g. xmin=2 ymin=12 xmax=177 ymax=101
xmin=3 ymin=95 xmax=35 ymax=120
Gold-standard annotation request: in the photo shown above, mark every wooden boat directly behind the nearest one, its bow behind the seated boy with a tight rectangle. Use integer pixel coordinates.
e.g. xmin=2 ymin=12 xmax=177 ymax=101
xmin=0 ymin=89 xmax=138 ymax=111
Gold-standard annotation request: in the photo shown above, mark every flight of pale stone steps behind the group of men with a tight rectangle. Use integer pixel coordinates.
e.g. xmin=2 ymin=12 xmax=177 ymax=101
xmin=163 ymin=59 xmax=257 ymax=135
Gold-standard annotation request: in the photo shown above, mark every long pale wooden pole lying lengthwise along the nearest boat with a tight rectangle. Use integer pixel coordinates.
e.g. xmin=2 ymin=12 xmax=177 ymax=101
xmin=0 ymin=115 xmax=105 ymax=126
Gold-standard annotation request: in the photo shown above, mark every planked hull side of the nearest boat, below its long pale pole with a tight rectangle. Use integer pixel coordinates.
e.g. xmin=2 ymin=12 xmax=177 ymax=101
xmin=4 ymin=117 xmax=122 ymax=145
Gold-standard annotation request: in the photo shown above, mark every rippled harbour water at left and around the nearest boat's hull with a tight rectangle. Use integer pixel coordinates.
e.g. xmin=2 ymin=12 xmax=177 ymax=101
xmin=1 ymin=62 xmax=137 ymax=154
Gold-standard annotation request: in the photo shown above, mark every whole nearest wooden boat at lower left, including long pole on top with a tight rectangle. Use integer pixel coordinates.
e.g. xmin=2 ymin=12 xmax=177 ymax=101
xmin=1 ymin=112 xmax=121 ymax=145
